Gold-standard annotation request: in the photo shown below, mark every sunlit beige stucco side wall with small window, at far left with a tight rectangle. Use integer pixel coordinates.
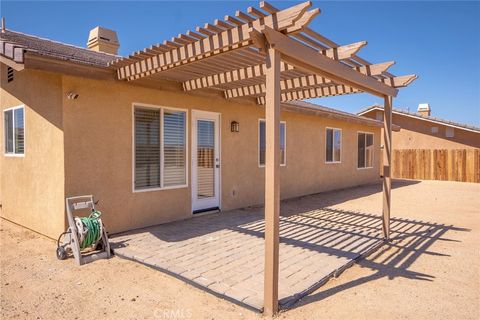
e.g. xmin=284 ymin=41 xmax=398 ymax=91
xmin=0 ymin=64 xmax=65 ymax=237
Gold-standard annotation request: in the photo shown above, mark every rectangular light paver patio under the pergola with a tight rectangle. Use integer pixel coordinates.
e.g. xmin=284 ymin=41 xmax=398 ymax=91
xmin=111 ymin=191 xmax=382 ymax=311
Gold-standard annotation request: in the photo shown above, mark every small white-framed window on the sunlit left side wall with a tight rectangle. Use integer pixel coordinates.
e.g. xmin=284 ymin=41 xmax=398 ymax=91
xmin=3 ymin=105 xmax=25 ymax=157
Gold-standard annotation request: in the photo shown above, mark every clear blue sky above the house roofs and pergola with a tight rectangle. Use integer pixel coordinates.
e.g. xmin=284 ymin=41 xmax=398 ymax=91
xmin=0 ymin=0 xmax=480 ymax=126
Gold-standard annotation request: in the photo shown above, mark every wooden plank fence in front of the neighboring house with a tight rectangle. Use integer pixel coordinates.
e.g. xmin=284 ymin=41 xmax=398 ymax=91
xmin=392 ymin=149 xmax=480 ymax=183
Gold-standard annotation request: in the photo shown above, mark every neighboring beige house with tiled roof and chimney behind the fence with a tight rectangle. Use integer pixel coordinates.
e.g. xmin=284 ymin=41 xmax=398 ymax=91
xmin=358 ymin=104 xmax=480 ymax=150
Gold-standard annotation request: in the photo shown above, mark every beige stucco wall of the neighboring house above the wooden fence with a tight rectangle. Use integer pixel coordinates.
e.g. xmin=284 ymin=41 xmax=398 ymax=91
xmin=363 ymin=110 xmax=480 ymax=150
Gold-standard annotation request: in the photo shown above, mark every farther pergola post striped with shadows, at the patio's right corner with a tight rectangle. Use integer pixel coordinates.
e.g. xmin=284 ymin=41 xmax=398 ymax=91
xmin=382 ymin=96 xmax=393 ymax=240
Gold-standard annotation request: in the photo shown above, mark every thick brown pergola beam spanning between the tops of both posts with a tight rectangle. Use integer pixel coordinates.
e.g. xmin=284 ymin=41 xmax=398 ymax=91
xmin=263 ymin=26 xmax=398 ymax=97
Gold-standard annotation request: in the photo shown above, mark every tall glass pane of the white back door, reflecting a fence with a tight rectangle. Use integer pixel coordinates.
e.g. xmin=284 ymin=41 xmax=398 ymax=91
xmin=197 ymin=120 xmax=215 ymax=199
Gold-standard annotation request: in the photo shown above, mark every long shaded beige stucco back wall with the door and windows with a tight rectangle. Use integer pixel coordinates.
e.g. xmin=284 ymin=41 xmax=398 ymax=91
xmin=62 ymin=76 xmax=380 ymax=232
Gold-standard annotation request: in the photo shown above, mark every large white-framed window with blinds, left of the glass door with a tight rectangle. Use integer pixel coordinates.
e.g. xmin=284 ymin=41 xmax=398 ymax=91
xmin=133 ymin=104 xmax=187 ymax=191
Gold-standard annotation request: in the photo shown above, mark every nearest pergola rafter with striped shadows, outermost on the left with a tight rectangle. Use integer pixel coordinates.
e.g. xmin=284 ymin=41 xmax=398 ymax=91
xmin=117 ymin=1 xmax=320 ymax=80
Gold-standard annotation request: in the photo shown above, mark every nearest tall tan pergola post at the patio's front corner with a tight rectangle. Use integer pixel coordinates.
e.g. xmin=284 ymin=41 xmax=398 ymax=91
xmin=263 ymin=47 xmax=281 ymax=316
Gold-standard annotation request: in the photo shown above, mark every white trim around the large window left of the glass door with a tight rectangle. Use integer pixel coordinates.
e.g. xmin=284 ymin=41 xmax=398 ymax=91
xmin=132 ymin=102 xmax=190 ymax=193
